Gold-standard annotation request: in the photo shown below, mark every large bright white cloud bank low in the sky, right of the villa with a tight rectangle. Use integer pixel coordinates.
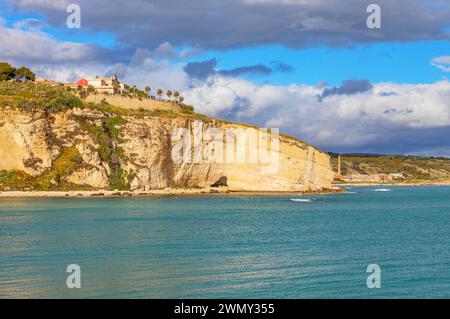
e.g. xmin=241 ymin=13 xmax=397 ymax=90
xmin=185 ymin=77 xmax=450 ymax=152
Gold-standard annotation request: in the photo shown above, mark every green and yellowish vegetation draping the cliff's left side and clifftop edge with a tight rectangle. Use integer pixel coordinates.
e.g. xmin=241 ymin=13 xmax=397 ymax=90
xmin=0 ymin=81 xmax=211 ymax=191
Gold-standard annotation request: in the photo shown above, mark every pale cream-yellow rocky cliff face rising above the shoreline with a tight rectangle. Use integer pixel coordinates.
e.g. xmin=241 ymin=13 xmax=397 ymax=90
xmin=0 ymin=107 xmax=332 ymax=191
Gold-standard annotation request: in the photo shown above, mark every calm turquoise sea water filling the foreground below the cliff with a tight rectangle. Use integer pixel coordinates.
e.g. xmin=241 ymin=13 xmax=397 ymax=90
xmin=0 ymin=187 xmax=450 ymax=298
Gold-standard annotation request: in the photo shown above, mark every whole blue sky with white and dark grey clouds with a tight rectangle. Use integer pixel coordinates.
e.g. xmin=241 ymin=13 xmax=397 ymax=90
xmin=0 ymin=0 xmax=450 ymax=156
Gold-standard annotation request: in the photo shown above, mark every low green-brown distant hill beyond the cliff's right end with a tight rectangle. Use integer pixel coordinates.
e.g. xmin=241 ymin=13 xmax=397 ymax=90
xmin=330 ymin=153 xmax=450 ymax=183
